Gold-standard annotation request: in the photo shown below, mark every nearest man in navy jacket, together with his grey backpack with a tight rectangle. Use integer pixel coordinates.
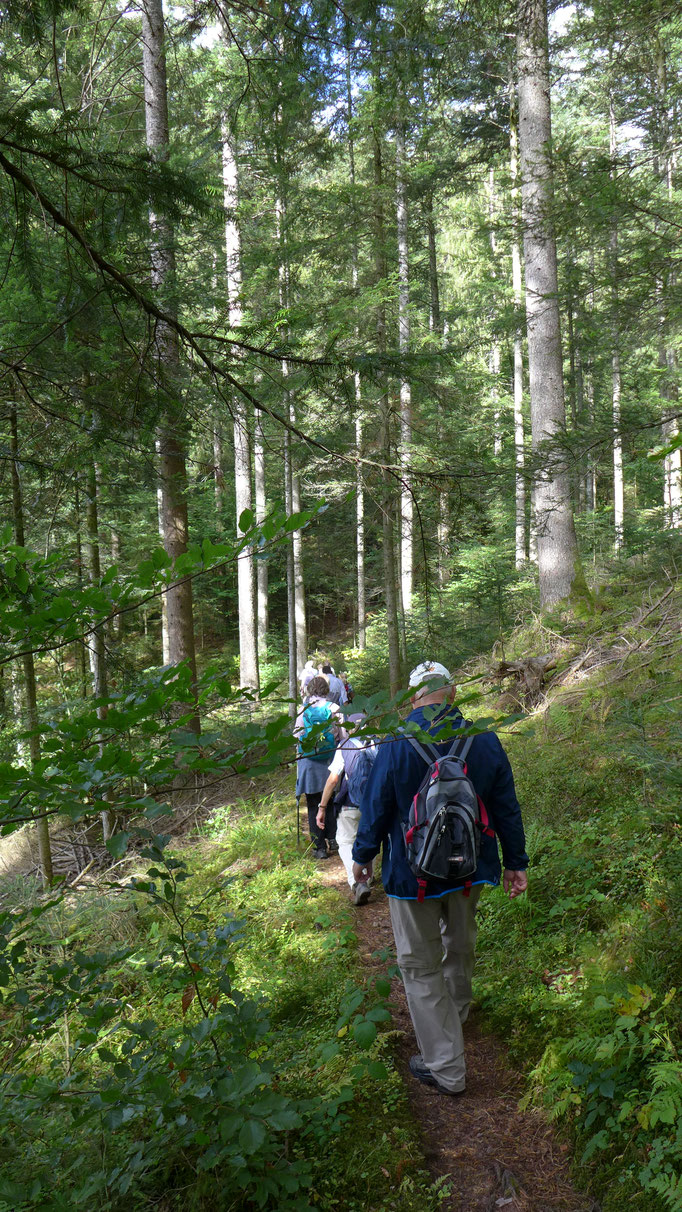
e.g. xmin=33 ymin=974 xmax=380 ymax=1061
xmin=353 ymin=661 xmax=528 ymax=1094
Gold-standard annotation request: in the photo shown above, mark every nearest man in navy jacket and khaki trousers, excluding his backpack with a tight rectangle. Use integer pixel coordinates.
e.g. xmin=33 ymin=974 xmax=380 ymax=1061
xmin=353 ymin=661 xmax=528 ymax=1094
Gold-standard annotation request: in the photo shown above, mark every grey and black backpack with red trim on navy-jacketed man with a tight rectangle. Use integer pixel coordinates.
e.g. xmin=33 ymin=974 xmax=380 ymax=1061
xmin=402 ymin=737 xmax=494 ymax=901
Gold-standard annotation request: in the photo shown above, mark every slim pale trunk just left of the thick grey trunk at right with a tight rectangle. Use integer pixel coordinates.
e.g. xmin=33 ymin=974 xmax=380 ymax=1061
xmin=509 ymin=85 xmax=527 ymax=568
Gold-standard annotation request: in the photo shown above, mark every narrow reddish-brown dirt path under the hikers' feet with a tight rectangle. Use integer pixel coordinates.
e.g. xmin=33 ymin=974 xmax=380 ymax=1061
xmin=319 ymin=857 xmax=600 ymax=1212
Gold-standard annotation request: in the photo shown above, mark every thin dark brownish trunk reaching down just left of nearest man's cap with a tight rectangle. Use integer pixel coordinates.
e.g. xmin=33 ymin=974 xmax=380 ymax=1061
xmin=372 ymin=127 xmax=401 ymax=694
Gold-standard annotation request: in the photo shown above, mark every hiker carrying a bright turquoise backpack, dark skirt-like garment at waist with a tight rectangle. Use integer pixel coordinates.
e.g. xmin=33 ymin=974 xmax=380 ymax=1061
xmin=293 ymin=675 xmax=348 ymax=858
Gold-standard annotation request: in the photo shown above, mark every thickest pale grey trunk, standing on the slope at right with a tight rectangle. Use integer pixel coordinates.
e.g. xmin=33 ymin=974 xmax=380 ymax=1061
xmin=517 ymin=0 xmax=581 ymax=606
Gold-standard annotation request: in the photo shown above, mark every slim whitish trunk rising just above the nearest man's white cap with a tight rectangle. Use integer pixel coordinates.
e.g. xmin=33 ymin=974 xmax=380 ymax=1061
xmin=395 ymin=122 xmax=414 ymax=616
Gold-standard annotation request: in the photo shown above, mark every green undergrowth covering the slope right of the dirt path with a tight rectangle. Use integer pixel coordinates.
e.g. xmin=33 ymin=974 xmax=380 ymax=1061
xmin=477 ymin=567 xmax=682 ymax=1212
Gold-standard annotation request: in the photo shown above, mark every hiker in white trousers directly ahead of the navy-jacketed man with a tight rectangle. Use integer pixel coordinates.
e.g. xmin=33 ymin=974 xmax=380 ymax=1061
xmin=316 ymin=713 xmax=377 ymax=905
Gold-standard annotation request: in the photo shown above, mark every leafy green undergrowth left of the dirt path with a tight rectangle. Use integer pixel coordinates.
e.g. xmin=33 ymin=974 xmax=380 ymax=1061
xmin=0 ymin=794 xmax=443 ymax=1212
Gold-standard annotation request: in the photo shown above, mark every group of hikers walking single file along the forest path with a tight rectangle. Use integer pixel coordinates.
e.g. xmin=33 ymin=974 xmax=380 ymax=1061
xmin=294 ymin=661 xmax=528 ymax=1096
